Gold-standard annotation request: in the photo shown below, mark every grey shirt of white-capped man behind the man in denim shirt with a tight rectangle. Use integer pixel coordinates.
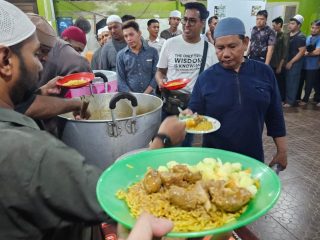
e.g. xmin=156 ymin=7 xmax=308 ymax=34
xmin=100 ymin=39 xmax=127 ymax=72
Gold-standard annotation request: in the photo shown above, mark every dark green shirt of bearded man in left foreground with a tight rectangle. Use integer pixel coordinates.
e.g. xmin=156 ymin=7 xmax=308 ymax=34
xmin=0 ymin=108 xmax=108 ymax=240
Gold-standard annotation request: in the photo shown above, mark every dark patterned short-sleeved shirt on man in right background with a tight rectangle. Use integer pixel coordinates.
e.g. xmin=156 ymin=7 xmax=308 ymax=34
xmin=250 ymin=26 xmax=276 ymax=60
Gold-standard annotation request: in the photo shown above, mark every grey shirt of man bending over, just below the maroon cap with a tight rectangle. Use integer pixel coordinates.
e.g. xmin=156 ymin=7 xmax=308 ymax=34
xmin=39 ymin=39 xmax=91 ymax=87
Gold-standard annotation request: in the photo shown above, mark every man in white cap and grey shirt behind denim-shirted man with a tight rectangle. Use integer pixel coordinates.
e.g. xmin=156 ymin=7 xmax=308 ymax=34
xmin=100 ymin=15 xmax=127 ymax=72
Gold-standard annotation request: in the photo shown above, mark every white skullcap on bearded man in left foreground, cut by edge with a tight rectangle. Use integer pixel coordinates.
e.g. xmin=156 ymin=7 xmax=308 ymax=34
xmin=0 ymin=0 xmax=36 ymax=47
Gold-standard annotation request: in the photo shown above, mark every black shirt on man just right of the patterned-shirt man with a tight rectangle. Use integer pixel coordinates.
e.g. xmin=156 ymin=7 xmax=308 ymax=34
xmin=270 ymin=32 xmax=289 ymax=68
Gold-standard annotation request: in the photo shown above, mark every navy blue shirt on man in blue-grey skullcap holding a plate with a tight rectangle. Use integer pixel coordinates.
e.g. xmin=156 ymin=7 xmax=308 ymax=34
xmin=189 ymin=60 xmax=286 ymax=161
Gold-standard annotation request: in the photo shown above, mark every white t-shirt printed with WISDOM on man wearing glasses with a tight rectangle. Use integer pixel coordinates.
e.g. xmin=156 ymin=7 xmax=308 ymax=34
xmin=157 ymin=35 xmax=218 ymax=93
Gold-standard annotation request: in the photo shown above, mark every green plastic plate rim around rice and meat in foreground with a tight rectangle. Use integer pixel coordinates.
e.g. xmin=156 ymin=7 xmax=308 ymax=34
xmin=97 ymin=147 xmax=281 ymax=238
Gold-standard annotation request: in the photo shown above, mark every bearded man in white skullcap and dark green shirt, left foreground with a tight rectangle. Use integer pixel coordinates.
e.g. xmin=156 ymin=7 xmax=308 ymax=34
xmin=0 ymin=0 xmax=184 ymax=240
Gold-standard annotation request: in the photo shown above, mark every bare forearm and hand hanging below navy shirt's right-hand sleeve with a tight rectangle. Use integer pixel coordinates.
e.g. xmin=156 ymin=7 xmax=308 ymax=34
xmin=269 ymin=137 xmax=288 ymax=170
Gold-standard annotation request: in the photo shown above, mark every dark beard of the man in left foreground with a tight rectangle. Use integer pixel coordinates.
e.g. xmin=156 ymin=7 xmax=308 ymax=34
xmin=9 ymin=54 xmax=38 ymax=106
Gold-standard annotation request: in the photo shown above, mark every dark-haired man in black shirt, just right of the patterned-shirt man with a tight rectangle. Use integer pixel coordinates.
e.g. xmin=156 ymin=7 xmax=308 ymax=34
xmin=270 ymin=17 xmax=288 ymax=102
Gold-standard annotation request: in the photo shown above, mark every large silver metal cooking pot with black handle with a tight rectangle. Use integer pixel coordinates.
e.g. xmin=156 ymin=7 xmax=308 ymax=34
xmin=58 ymin=93 xmax=162 ymax=169
